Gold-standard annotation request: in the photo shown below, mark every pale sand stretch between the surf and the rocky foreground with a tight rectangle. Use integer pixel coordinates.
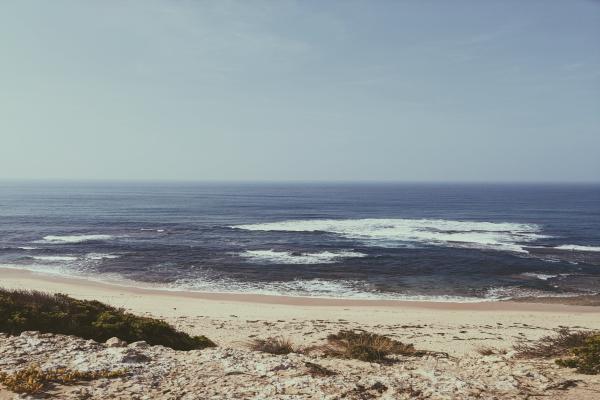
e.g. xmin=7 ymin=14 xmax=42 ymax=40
xmin=0 ymin=268 xmax=600 ymax=355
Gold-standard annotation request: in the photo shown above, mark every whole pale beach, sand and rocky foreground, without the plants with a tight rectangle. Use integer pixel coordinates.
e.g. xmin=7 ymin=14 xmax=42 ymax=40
xmin=0 ymin=269 xmax=600 ymax=400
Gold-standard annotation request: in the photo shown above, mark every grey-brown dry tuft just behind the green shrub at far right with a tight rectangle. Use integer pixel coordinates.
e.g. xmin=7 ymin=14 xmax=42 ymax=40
xmin=514 ymin=328 xmax=597 ymax=358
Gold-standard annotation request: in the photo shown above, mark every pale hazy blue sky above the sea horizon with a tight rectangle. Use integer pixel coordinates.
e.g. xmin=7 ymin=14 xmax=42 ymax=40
xmin=0 ymin=0 xmax=600 ymax=182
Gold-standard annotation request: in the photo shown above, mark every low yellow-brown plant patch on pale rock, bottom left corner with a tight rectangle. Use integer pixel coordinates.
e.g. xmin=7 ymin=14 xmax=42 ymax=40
xmin=0 ymin=364 xmax=126 ymax=394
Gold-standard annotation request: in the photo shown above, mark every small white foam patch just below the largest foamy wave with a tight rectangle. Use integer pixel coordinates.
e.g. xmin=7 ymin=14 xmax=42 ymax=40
xmin=240 ymin=250 xmax=366 ymax=264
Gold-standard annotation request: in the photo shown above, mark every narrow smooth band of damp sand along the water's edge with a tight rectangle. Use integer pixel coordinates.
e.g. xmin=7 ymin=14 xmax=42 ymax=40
xmin=0 ymin=267 xmax=600 ymax=313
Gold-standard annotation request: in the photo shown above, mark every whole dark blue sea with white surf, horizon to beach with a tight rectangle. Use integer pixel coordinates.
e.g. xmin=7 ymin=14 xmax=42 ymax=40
xmin=0 ymin=182 xmax=600 ymax=301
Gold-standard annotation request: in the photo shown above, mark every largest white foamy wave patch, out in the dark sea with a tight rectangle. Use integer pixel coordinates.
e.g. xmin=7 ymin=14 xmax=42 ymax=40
xmin=232 ymin=218 xmax=548 ymax=253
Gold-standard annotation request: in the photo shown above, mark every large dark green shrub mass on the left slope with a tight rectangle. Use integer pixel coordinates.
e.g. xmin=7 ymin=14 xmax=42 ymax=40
xmin=0 ymin=289 xmax=215 ymax=350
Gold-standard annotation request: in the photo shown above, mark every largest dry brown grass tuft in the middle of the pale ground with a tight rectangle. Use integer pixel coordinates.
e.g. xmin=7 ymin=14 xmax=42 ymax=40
xmin=323 ymin=331 xmax=424 ymax=362
